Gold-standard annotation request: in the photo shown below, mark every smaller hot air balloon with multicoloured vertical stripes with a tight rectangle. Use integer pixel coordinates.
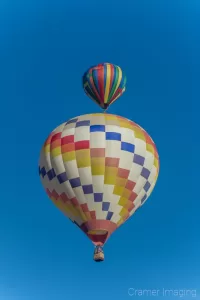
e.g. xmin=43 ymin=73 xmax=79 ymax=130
xmin=83 ymin=63 xmax=126 ymax=110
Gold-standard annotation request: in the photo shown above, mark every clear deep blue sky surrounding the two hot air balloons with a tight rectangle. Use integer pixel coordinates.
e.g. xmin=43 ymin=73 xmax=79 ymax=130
xmin=0 ymin=0 xmax=200 ymax=300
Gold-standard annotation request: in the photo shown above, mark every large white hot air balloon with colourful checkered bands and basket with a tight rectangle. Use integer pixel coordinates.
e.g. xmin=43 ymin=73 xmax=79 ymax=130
xmin=39 ymin=113 xmax=159 ymax=261
